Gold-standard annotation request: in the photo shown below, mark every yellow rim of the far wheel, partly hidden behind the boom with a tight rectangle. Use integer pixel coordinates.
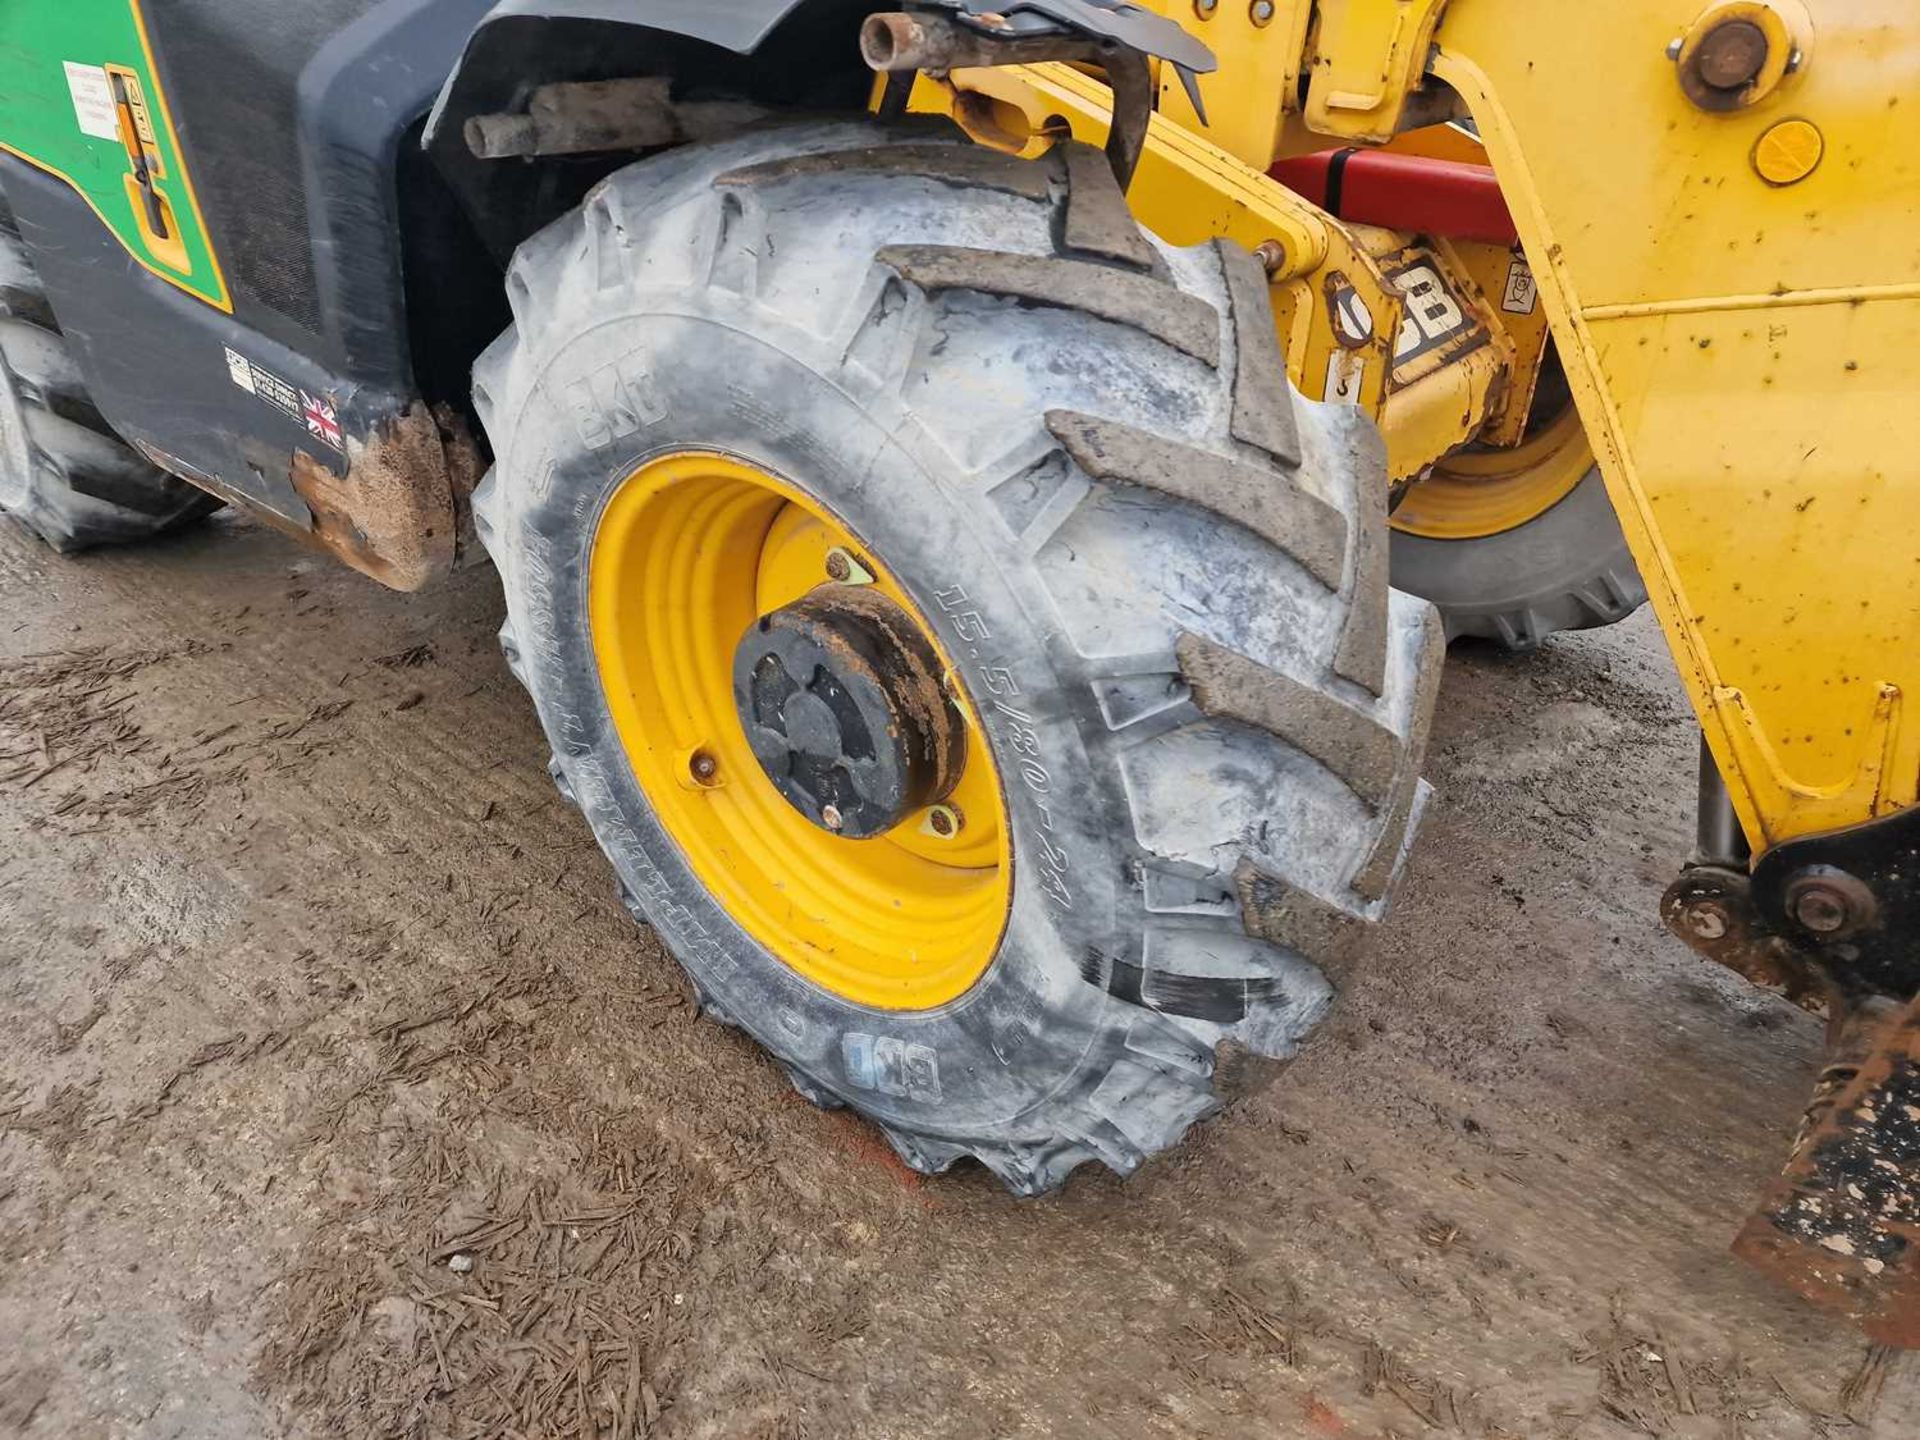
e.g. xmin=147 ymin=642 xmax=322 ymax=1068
xmin=1394 ymin=405 xmax=1594 ymax=540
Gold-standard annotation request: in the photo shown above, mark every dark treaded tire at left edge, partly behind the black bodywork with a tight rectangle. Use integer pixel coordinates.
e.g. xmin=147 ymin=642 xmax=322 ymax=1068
xmin=0 ymin=202 xmax=221 ymax=551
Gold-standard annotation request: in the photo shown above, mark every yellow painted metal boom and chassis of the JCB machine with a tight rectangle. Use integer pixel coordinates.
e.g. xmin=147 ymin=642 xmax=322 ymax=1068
xmin=914 ymin=0 xmax=1920 ymax=852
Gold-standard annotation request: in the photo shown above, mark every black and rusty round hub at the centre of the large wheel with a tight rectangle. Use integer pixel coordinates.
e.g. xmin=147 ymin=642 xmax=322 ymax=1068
xmin=733 ymin=586 xmax=966 ymax=839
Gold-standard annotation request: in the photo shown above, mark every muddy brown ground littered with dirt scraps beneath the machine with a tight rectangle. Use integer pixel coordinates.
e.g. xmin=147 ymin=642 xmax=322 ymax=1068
xmin=0 ymin=520 xmax=1920 ymax=1440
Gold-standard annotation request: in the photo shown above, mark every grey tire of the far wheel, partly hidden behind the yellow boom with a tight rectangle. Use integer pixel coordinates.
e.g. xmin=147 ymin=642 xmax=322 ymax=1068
xmin=1392 ymin=467 xmax=1647 ymax=651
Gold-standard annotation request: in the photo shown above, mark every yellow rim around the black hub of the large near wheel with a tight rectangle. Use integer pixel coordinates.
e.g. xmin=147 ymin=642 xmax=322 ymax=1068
xmin=588 ymin=451 xmax=1012 ymax=1010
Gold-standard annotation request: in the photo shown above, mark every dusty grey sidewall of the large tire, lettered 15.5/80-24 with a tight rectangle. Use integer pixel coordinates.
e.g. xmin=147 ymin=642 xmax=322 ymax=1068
xmin=492 ymin=298 xmax=1139 ymax=1139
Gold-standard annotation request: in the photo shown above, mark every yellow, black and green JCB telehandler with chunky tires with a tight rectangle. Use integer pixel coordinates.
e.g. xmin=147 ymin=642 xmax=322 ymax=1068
xmin=0 ymin=0 xmax=1920 ymax=1346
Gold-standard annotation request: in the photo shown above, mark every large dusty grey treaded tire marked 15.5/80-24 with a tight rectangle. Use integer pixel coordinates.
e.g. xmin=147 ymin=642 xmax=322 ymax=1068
xmin=474 ymin=123 xmax=1444 ymax=1194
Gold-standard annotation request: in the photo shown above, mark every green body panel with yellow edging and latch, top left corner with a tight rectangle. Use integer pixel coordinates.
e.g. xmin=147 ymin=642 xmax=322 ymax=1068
xmin=0 ymin=0 xmax=228 ymax=309
